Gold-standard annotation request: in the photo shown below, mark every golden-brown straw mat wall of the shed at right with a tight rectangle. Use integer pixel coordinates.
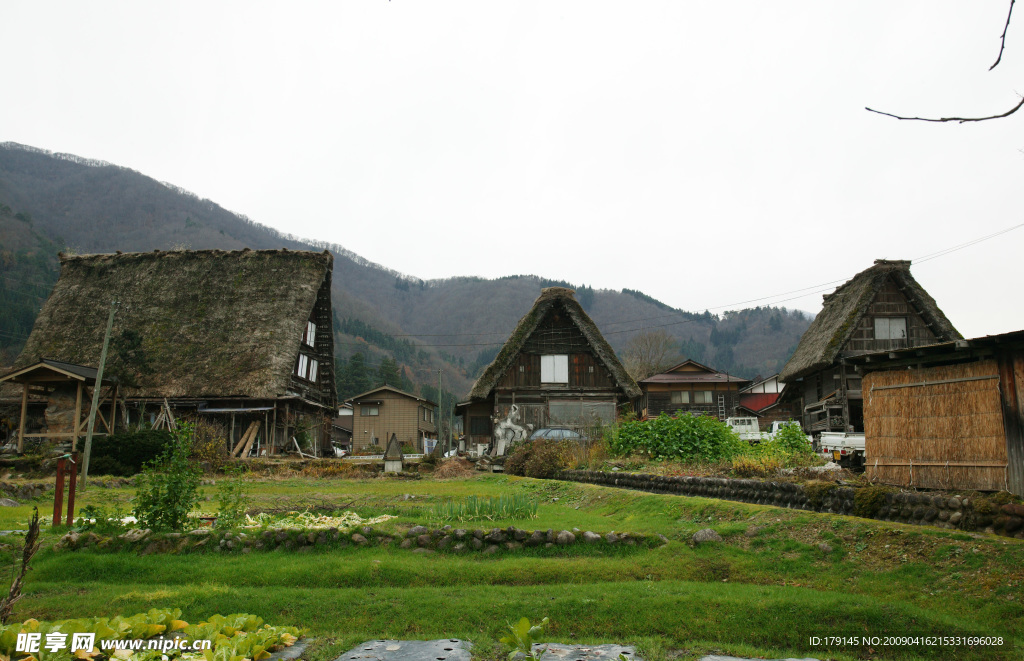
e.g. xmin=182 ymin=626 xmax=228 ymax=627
xmin=863 ymin=360 xmax=1007 ymax=490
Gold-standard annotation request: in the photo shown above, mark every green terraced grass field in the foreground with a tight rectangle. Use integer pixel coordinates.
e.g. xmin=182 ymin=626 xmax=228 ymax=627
xmin=0 ymin=475 xmax=1024 ymax=661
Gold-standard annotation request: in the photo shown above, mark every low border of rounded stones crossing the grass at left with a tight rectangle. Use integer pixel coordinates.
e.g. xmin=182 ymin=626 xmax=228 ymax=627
xmin=55 ymin=526 xmax=668 ymax=556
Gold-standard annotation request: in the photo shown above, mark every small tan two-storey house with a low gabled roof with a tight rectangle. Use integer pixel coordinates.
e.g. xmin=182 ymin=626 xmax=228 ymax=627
xmin=345 ymin=386 xmax=437 ymax=454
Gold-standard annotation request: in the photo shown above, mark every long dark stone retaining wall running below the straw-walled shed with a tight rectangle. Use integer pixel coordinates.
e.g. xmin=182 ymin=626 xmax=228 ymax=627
xmin=557 ymin=471 xmax=1024 ymax=539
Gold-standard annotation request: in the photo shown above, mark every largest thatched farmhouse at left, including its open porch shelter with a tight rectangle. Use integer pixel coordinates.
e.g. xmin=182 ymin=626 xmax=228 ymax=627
xmin=0 ymin=249 xmax=336 ymax=453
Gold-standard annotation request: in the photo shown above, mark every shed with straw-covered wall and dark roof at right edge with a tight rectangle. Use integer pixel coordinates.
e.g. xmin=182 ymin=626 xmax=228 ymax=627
xmin=849 ymin=331 xmax=1024 ymax=495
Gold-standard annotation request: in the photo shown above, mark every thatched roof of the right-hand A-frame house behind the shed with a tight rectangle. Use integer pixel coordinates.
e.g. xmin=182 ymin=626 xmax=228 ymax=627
xmin=779 ymin=260 xmax=962 ymax=382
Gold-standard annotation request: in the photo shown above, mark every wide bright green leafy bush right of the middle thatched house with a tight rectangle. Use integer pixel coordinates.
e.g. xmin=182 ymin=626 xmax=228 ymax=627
xmin=609 ymin=413 xmax=749 ymax=461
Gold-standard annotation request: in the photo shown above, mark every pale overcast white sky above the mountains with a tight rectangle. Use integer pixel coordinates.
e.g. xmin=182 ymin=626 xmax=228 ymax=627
xmin=0 ymin=0 xmax=1024 ymax=337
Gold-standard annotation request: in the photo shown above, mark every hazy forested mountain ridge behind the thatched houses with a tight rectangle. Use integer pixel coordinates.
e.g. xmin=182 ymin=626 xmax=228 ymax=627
xmin=0 ymin=142 xmax=810 ymax=397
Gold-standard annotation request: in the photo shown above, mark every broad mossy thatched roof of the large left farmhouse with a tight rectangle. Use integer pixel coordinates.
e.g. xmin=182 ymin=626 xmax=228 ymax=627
xmin=15 ymin=249 xmax=334 ymax=398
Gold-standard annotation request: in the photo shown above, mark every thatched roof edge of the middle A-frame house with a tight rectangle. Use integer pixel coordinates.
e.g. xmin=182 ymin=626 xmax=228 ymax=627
xmin=469 ymin=287 xmax=643 ymax=399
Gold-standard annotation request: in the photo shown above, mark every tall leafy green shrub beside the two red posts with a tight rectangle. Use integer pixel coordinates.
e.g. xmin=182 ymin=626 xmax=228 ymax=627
xmin=132 ymin=423 xmax=200 ymax=530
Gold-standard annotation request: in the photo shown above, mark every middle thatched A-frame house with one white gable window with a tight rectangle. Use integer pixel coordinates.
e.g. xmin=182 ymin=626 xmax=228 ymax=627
xmin=457 ymin=287 xmax=641 ymax=455
